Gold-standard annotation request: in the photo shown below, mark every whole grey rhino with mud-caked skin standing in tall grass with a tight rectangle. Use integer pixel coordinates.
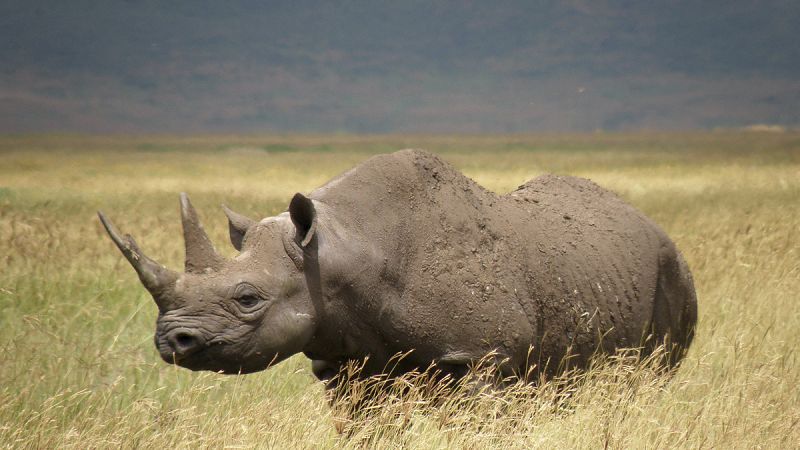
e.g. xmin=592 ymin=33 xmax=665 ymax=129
xmin=100 ymin=150 xmax=697 ymax=379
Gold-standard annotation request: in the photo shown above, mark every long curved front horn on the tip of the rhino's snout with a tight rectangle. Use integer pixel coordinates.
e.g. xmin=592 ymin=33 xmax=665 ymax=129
xmin=97 ymin=211 xmax=178 ymax=309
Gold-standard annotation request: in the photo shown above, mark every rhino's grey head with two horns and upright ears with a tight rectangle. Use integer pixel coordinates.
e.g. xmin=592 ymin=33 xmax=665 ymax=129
xmin=98 ymin=194 xmax=318 ymax=374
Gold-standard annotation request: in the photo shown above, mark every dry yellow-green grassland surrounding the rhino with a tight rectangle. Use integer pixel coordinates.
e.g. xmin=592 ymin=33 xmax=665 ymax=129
xmin=0 ymin=132 xmax=800 ymax=449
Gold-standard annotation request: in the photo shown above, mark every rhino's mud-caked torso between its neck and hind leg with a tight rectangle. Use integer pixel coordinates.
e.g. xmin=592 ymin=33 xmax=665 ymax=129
xmin=312 ymin=150 xmax=680 ymax=374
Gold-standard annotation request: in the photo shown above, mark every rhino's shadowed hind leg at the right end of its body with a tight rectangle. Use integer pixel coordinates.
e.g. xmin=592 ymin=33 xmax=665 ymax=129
xmin=644 ymin=245 xmax=697 ymax=368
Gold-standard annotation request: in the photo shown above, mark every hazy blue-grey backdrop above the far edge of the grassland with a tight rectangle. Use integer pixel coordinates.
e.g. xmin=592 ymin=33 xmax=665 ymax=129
xmin=0 ymin=0 xmax=800 ymax=132
